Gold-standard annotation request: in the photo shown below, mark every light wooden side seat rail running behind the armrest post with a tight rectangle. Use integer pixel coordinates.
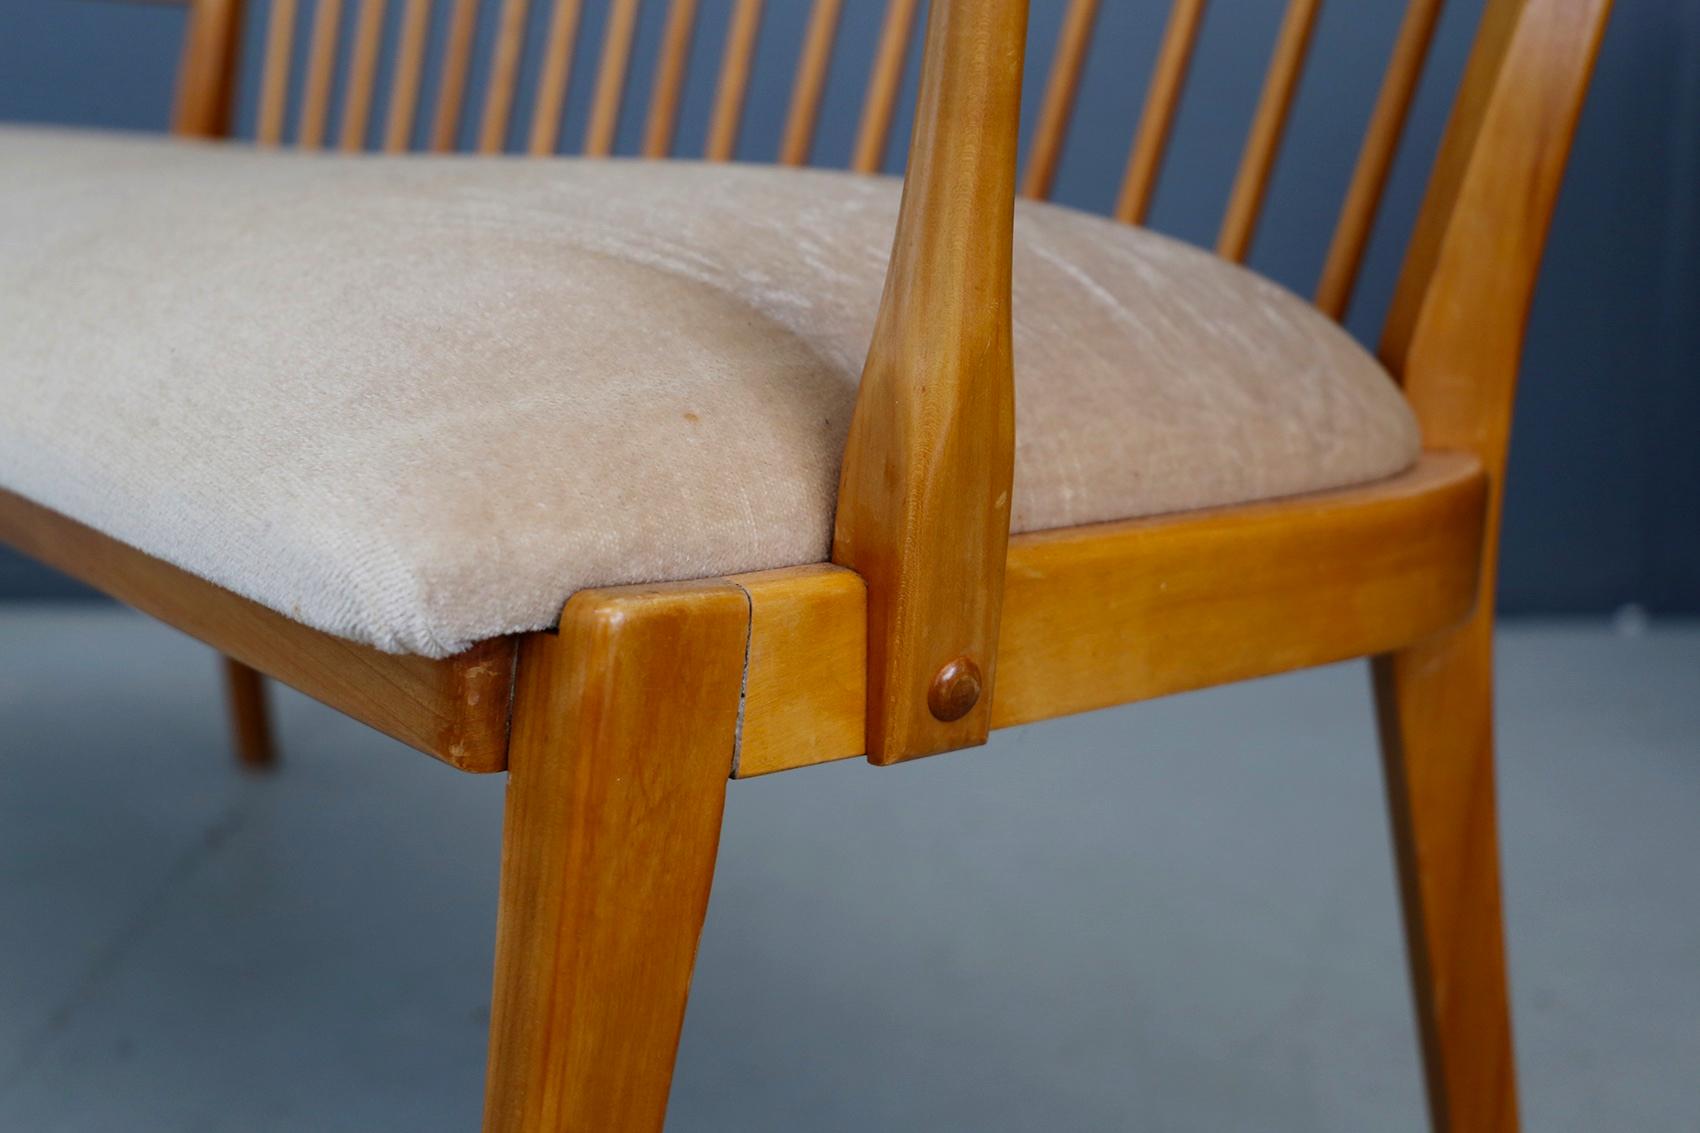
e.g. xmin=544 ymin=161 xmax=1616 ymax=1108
xmin=751 ymin=453 xmax=1488 ymax=776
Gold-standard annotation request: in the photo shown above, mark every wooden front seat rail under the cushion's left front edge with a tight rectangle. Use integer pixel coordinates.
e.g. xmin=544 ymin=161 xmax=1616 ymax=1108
xmin=0 ymin=490 xmax=513 ymax=771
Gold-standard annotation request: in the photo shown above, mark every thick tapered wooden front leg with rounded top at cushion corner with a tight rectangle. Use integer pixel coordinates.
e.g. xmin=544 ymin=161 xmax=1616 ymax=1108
xmin=485 ymin=582 xmax=750 ymax=1133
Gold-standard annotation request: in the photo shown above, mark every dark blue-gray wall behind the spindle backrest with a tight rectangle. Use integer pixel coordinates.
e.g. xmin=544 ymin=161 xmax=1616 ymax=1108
xmin=0 ymin=0 xmax=1700 ymax=612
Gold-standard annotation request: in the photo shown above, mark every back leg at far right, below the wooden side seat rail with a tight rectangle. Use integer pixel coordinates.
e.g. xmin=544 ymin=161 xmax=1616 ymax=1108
xmin=1374 ymin=609 xmax=1518 ymax=1133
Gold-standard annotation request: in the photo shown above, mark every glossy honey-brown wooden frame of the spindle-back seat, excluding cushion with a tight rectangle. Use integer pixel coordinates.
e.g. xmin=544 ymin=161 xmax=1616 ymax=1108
xmin=0 ymin=0 xmax=1610 ymax=1131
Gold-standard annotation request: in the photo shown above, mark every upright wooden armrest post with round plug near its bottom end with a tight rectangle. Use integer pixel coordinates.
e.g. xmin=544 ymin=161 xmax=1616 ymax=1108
xmin=833 ymin=0 xmax=1027 ymax=764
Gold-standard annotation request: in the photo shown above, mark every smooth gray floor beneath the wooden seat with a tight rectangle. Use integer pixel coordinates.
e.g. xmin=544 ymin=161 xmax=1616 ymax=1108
xmin=0 ymin=606 xmax=1700 ymax=1133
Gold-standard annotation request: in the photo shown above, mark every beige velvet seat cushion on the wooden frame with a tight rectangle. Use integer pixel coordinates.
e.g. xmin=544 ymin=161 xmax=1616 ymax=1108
xmin=0 ymin=128 xmax=1418 ymax=655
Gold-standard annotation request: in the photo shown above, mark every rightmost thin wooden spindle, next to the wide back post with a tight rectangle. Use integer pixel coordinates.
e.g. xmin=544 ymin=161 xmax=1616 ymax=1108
xmin=1316 ymin=0 xmax=1443 ymax=318
